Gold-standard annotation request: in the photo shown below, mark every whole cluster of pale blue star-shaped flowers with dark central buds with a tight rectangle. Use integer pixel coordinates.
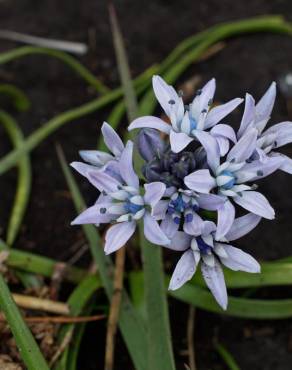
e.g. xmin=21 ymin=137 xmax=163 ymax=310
xmin=72 ymin=76 xmax=292 ymax=309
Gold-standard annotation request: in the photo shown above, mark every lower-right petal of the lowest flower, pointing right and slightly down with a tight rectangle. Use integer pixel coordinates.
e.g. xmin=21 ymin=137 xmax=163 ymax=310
xmin=219 ymin=244 xmax=261 ymax=273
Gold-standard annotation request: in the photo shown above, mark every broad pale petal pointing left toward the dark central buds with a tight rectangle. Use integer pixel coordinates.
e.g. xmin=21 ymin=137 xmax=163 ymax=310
xmin=184 ymin=169 xmax=216 ymax=194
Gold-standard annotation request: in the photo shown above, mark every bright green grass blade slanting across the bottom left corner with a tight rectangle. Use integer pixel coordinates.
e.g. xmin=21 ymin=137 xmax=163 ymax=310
xmin=0 ymin=274 xmax=49 ymax=370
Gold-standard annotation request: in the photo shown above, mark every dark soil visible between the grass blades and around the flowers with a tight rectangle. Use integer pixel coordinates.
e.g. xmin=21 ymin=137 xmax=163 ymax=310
xmin=0 ymin=0 xmax=292 ymax=370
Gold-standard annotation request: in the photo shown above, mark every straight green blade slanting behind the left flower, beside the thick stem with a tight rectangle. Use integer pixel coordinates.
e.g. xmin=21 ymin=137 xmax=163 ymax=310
xmin=58 ymin=145 xmax=148 ymax=370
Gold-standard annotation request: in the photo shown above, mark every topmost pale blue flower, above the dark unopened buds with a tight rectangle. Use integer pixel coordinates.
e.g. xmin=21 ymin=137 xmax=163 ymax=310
xmin=128 ymin=76 xmax=243 ymax=155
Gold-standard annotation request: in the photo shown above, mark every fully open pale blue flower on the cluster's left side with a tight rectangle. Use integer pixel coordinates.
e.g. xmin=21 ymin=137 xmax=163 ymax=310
xmin=72 ymin=141 xmax=170 ymax=254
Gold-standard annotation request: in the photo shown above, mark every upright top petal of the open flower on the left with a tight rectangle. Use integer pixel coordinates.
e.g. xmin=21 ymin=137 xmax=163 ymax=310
xmin=119 ymin=140 xmax=139 ymax=189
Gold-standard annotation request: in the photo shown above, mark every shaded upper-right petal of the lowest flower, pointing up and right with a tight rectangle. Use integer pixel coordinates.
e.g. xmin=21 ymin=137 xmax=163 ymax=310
xmin=225 ymin=213 xmax=261 ymax=241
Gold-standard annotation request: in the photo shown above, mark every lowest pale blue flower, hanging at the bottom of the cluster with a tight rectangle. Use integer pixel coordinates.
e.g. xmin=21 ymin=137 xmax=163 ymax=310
xmin=168 ymin=213 xmax=260 ymax=310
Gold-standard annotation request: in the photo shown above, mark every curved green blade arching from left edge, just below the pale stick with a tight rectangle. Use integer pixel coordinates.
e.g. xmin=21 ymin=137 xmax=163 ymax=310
xmin=0 ymin=46 xmax=109 ymax=94
